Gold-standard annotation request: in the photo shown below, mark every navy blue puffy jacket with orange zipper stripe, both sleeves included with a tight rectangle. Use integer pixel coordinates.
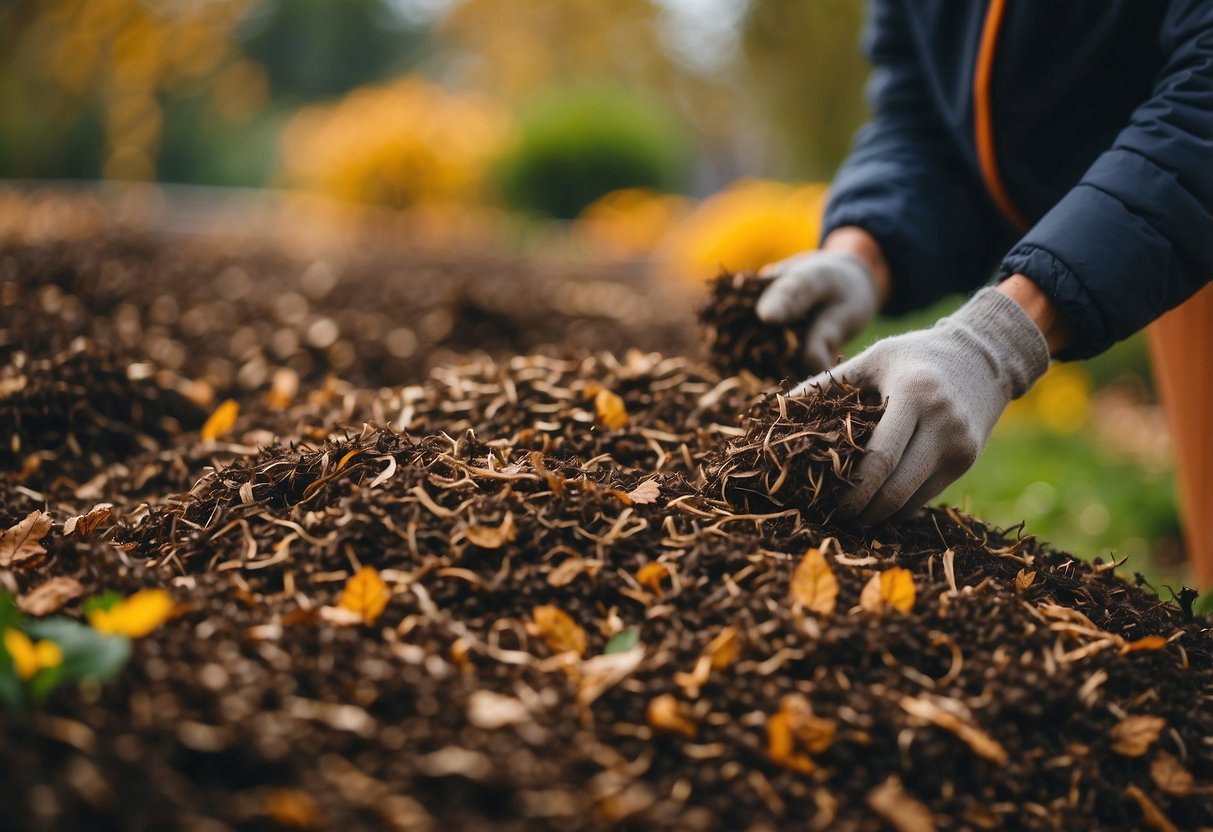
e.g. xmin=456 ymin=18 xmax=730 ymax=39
xmin=822 ymin=0 xmax=1213 ymax=358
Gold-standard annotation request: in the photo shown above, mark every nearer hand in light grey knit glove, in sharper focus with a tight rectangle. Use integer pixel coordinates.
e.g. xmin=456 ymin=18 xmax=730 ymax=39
xmin=792 ymin=289 xmax=1049 ymax=524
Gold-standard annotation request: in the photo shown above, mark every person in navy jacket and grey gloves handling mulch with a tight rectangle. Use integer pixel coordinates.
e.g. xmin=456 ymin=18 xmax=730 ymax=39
xmin=758 ymin=0 xmax=1213 ymax=581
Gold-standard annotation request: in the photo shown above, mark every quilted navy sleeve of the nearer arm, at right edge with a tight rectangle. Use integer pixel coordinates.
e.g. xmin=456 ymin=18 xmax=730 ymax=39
xmin=1000 ymin=0 xmax=1213 ymax=359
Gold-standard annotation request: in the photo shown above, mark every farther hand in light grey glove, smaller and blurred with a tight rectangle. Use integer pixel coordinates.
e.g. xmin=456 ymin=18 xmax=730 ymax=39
xmin=757 ymin=251 xmax=879 ymax=372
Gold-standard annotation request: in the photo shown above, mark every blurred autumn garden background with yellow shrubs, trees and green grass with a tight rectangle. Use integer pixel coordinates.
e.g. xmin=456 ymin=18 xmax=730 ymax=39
xmin=0 ymin=0 xmax=1183 ymax=587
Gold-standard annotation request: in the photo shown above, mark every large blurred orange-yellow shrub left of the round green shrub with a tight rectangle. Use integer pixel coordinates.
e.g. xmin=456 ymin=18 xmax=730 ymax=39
xmin=281 ymin=76 xmax=512 ymax=207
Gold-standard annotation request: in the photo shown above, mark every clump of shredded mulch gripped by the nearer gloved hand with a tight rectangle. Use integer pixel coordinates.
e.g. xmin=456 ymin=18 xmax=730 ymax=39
xmin=712 ymin=382 xmax=884 ymax=518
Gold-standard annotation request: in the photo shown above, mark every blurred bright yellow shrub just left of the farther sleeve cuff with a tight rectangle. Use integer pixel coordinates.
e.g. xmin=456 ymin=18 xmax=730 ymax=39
xmin=656 ymin=179 xmax=826 ymax=281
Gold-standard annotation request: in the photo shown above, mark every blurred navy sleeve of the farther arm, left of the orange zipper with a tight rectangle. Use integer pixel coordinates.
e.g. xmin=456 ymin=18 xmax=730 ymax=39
xmin=821 ymin=0 xmax=1008 ymax=313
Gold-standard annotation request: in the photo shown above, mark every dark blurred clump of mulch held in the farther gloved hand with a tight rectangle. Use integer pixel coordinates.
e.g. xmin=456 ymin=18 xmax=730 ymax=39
xmin=699 ymin=272 xmax=805 ymax=381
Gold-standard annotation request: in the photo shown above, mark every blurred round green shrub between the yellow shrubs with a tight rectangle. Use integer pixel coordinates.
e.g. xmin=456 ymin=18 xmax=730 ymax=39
xmin=497 ymin=89 xmax=689 ymax=220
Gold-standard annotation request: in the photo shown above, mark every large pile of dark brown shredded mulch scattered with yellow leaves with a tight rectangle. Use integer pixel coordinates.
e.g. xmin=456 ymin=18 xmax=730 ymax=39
xmin=0 ymin=204 xmax=1213 ymax=832
